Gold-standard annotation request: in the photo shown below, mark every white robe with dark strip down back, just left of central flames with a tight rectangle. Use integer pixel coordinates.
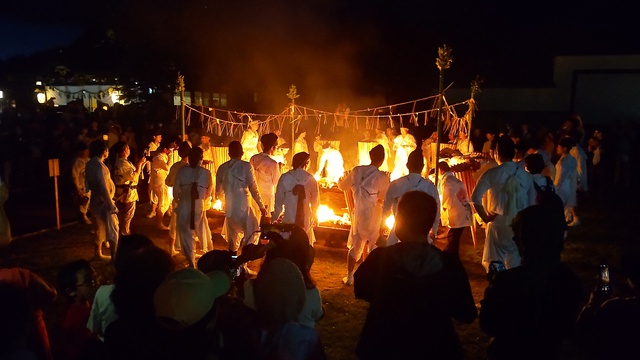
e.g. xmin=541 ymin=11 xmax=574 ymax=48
xmin=272 ymin=168 xmax=320 ymax=245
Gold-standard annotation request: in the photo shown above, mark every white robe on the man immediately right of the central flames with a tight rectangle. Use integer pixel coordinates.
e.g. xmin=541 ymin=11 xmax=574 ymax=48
xmin=338 ymin=165 xmax=389 ymax=259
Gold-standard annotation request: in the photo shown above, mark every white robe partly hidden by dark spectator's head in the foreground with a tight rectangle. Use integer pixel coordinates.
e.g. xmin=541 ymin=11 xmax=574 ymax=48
xmin=382 ymin=173 xmax=440 ymax=246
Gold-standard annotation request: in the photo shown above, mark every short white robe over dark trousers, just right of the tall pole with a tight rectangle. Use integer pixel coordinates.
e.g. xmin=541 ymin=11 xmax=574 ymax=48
xmin=438 ymin=172 xmax=473 ymax=229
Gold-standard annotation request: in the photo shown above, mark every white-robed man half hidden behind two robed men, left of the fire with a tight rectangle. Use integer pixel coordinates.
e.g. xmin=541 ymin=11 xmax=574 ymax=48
xmin=249 ymin=133 xmax=280 ymax=214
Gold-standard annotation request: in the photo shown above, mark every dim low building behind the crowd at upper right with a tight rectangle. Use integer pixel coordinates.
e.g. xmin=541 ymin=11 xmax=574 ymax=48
xmin=445 ymin=55 xmax=640 ymax=124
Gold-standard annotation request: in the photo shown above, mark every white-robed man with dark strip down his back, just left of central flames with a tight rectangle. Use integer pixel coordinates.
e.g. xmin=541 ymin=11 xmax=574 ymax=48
xmin=272 ymin=153 xmax=320 ymax=246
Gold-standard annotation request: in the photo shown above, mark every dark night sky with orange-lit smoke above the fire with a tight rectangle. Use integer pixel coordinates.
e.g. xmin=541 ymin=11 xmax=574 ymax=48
xmin=0 ymin=0 xmax=640 ymax=109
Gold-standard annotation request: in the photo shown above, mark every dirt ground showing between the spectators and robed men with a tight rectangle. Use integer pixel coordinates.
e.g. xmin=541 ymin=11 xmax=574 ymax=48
xmin=2 ymin=187 xmax=638 ymax=359
